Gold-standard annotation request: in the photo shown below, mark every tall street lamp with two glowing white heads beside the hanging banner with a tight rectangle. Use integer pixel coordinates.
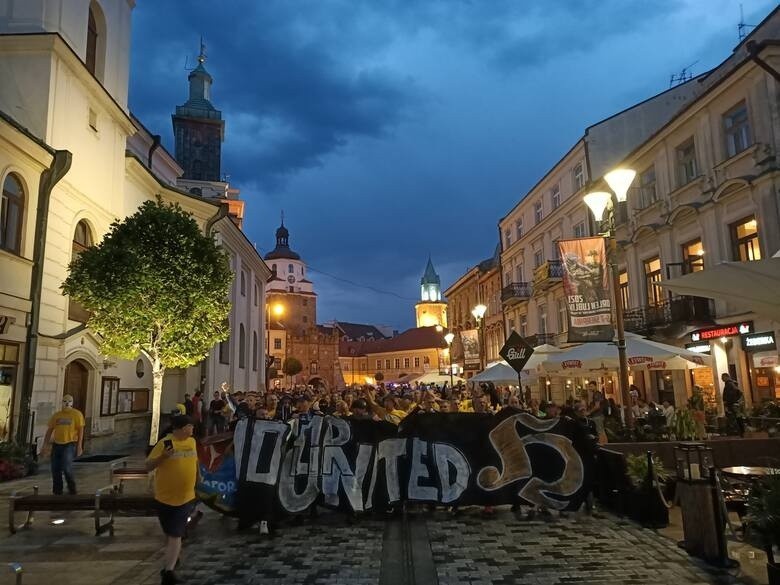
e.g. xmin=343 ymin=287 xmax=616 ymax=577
xmin=582 ymin=168 xmax=636 ymax=428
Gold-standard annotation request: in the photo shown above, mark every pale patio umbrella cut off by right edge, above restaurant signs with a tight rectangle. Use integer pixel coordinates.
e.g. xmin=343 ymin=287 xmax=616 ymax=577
xmin=660 ymin=257 xmax=780 ymax=321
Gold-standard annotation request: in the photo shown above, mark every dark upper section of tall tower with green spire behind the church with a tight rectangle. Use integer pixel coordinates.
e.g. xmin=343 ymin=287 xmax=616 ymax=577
xmin=172 ymin=42 xmax=225 ymax=181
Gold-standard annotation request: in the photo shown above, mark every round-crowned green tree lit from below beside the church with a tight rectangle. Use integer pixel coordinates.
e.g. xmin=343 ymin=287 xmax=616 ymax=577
xmin=62 ymin=198 xmax=233 ymax=444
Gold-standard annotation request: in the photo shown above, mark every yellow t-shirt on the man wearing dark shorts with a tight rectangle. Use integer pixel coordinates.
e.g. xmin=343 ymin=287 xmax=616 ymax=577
xmin=149 ymin=435 xmax=198 ymax=506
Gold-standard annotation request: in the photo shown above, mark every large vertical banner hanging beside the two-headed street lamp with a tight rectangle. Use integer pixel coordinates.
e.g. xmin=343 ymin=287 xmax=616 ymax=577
xmin=558 ymin=237 xmax=615 ymax=343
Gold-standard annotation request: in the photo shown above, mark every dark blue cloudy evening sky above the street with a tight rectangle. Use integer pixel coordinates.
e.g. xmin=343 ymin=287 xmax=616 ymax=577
xmin=130 ymin=0 xmax=776 ymax=329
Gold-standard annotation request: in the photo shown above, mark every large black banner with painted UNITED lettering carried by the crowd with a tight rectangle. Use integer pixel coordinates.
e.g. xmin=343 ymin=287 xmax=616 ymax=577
xmin=198 ymin=409 xmax=592 ymax=518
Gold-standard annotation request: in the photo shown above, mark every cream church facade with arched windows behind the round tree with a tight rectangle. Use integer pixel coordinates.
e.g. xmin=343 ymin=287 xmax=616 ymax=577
xmin=0 ymin=0 xmax=269 ymax=452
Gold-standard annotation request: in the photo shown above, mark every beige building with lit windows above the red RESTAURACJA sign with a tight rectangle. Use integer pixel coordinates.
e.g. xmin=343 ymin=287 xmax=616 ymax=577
xmin=595 ymin=10 xmax=780 ymax=405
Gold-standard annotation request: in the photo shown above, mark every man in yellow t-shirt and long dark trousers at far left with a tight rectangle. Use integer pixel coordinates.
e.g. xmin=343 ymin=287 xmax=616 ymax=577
xmin=43 ymin=394 xmax=84 ymax=496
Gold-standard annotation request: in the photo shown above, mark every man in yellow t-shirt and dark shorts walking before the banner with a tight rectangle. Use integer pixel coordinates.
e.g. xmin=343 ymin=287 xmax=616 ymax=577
xmin=146 ymin=415 xmax=198 ymax=585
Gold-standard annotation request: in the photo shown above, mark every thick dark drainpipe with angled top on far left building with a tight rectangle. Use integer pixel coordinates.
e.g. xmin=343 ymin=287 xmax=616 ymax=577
xmin=16 ymin=150 xmax=73 ymax=444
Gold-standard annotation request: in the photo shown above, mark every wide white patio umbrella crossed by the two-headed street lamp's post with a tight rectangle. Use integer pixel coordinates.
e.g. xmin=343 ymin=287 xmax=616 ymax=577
xmin=539 ymin=333 xmax=709 ymax=374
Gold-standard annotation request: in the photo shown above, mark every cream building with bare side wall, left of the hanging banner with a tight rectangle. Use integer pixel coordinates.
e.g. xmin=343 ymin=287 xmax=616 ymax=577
xmin=499 ymin=74 xmax=698 ymax=358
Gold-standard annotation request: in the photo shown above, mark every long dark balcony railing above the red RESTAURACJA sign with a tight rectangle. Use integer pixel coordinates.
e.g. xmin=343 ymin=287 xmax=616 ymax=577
xmin=623 ymin=297 xmax=715 ymax=333
